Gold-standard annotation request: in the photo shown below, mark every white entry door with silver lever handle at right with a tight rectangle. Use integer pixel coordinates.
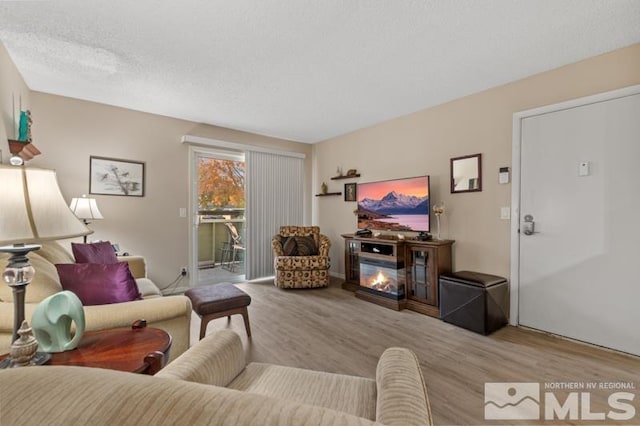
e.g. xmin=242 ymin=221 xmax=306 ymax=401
xmin=514 ymin=90 xmax=640 ymax=355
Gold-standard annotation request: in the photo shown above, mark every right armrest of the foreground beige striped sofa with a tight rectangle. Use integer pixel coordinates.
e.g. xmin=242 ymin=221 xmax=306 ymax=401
xmin=376 ymin=348 xmax=433 ymax=426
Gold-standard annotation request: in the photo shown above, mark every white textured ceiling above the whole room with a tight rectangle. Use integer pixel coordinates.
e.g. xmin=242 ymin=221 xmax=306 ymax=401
xmin=0 ymin=0 xmax=640 ymax=142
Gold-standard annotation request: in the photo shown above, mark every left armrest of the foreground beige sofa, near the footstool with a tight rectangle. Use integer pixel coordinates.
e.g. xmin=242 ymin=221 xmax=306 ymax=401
xmin=156 ymin=330 xmax=246 ymax=387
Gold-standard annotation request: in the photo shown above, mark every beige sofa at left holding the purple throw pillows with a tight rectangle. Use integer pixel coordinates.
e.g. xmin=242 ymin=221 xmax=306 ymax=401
xmin=0 ymin=242 xmax=191 ymax=359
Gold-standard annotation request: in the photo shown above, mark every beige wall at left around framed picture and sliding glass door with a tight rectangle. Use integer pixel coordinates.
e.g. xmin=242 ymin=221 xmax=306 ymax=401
xmin=0 ymin=40 xmax=312 ymax=287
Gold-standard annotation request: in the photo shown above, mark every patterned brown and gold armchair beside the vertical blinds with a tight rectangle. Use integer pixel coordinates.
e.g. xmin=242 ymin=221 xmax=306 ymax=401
xmin=271 ymin=226 xmax=331 ymax=288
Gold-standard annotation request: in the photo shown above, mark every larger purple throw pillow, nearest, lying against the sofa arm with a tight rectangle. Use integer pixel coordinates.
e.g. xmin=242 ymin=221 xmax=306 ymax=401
xmin=56 ymin=262 xmax=140 ymax=306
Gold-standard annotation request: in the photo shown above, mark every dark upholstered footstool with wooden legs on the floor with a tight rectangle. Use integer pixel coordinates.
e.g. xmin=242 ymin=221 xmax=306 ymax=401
xmin=184 ymin=284 xmax=251 ymax=339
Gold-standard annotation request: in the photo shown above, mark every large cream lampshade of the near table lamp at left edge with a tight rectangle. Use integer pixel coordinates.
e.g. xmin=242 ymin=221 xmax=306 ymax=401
xmin=0 ymin=165 xmax=93 ymax=245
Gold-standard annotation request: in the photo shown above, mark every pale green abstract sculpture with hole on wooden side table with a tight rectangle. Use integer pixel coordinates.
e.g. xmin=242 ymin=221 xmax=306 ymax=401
xmin=31 ymin=291 xmax=85 ymax=352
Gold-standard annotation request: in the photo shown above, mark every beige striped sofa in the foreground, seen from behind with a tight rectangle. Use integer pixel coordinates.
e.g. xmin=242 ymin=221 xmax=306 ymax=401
xmin=0 ymin=330 xmax=432 ymax=426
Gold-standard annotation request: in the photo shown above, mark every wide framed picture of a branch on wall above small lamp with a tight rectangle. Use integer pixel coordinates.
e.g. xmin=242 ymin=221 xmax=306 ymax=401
xmin=89 ymin=156 xmax=145 ymax=197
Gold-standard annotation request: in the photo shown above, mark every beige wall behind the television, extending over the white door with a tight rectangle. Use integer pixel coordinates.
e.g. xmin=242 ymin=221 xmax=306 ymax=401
xmin=313 ymin=44 xmax=640 ymax=277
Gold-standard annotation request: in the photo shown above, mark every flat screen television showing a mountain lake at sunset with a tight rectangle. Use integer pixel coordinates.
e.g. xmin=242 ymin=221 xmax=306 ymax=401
xmin=357 ymin=176 xmax=430 ymax=232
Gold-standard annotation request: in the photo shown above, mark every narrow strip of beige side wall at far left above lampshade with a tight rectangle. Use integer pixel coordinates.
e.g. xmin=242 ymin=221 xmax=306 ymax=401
xmin=0 ymin=43 xmax=31 ymax=158
